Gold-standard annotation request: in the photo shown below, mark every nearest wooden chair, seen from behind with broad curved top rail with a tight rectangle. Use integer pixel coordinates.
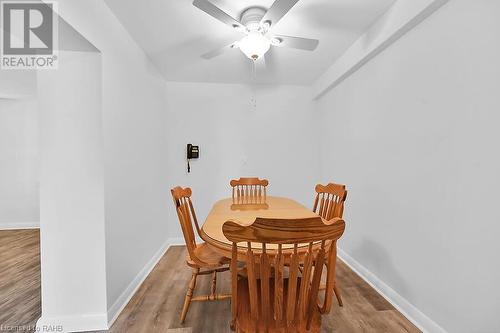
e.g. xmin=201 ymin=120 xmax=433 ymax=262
xmin=222 ymin=217 xmax=345 ymax=333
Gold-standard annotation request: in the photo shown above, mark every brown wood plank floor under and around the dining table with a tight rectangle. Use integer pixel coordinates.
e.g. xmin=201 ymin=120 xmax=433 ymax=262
xmin=109 ymin=246 xmax=420 ymax=333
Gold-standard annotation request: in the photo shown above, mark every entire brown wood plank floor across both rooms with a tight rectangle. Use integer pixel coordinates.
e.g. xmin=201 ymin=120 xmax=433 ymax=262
xmin=0 ymin=230 xmax=420 ymax=333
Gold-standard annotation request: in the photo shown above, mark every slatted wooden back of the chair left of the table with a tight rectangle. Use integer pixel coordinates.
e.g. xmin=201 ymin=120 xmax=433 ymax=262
xmin=170 ymin=186 xmax=201 ymax=260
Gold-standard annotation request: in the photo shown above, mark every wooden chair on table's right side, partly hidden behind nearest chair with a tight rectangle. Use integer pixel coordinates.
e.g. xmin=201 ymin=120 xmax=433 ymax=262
xmin=313 ymin=183 xmax=347 ymax=306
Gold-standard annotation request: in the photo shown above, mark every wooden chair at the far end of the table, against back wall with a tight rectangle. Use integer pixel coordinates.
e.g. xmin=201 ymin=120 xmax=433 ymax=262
xmin=229 ymin=177 xmax=269 ymax=204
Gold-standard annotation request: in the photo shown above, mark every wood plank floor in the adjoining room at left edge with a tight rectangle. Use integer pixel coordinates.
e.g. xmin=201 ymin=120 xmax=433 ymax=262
xmin=0 ymin=230 xmax=41 ymax=333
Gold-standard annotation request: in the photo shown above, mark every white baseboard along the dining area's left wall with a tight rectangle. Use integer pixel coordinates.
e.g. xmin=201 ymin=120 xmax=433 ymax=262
xmin=108 ymin=238 xmax=184 ymax=327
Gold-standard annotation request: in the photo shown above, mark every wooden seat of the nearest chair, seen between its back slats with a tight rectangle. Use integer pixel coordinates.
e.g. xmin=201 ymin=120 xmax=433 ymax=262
xmin=235 ymin=277 xmax=321 ymax=333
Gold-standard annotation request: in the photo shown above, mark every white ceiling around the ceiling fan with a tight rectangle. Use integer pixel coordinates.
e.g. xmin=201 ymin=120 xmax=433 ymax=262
xmin=105 ymin=0 xmax=395 ymax=85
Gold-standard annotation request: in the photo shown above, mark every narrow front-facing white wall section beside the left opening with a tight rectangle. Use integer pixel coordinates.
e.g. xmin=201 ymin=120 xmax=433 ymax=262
xmin=38 ymin=52 xmax=107 ymax=332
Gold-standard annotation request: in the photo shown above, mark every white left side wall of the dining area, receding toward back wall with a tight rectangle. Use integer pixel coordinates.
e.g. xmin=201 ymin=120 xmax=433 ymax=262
xmin=49 ymin=0 xmax=171 ymax=320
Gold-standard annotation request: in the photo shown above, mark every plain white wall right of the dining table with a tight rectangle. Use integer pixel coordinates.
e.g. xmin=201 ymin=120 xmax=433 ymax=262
xmin=318 ymin=0 xmax=500 ymax=333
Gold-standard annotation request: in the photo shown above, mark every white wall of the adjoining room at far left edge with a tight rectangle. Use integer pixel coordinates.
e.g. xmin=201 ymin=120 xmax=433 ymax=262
xmin=0 ymin=97 xmax=40 ymax=229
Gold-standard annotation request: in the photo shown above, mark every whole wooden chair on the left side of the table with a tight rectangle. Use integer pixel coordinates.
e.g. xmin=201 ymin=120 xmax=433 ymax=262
xmin=170 ymin=186 xmax=231 ymax=323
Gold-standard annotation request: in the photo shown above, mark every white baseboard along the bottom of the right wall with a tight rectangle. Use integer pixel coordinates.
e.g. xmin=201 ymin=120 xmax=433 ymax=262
xmin=337 ymin=248 xmax=447 ymax=333
